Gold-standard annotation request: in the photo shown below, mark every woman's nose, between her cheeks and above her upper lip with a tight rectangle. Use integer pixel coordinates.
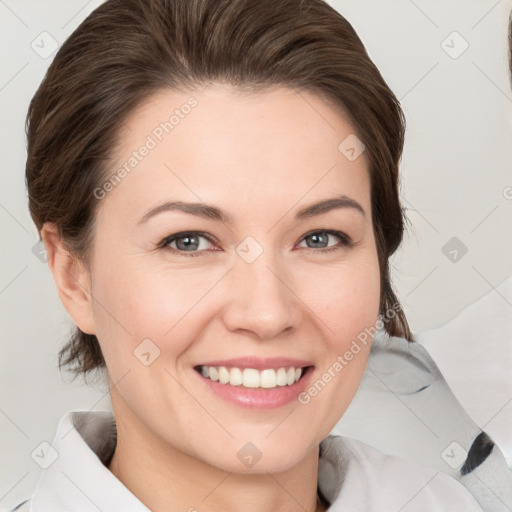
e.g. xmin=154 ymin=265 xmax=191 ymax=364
xmin=223 ymin=252 xmax=301 ymax=340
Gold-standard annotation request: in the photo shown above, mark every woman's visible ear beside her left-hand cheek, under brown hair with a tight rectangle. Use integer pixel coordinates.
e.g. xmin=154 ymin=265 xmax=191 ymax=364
xmin=41 ymin=222 xmax=95 ymax=334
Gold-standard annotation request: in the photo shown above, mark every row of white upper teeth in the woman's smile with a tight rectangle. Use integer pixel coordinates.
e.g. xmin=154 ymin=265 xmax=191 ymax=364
xmin=200 ymin=366 xmax=302 ymax=389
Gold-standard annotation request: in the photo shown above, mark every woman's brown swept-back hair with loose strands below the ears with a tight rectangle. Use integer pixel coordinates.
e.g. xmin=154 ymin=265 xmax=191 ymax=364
xmin=26 ymin=0 xmax=413 ymax=377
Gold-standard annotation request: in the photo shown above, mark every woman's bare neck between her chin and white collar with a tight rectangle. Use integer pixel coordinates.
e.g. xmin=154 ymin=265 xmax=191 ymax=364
xmin=108 ymin=404 xmax=326 ymax=512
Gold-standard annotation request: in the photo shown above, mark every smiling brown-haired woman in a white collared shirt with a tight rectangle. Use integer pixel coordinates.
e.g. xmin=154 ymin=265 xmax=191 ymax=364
xmin=13 ymin=0 xmax=488 ymax=511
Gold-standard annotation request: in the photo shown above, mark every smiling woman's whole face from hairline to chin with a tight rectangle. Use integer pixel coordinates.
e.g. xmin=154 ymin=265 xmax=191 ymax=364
xmin=85 ymin=84 xmax=380 ymax=472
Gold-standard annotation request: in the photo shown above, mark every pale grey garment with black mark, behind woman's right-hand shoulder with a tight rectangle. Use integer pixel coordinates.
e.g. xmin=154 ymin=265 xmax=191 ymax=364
xmin=332 ymin=330 xmax=512 ymax=512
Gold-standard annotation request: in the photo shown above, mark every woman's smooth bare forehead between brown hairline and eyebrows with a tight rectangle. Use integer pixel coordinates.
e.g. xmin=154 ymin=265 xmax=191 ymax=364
xmin=100 ymin=84 xmax=370 ymax=225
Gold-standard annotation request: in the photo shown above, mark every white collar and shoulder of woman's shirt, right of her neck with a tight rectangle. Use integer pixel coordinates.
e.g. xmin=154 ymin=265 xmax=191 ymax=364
xmin=319 ymin=436 xmax=482 ymax=512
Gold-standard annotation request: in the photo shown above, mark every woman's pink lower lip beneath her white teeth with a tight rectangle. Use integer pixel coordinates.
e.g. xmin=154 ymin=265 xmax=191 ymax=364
xmin=193 ymin=366 xmax=314 ymax=409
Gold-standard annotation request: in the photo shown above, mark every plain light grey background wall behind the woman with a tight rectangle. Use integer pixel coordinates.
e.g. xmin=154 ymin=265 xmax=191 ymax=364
xmin=0 ymin=0 xmax=512 ymax=509
